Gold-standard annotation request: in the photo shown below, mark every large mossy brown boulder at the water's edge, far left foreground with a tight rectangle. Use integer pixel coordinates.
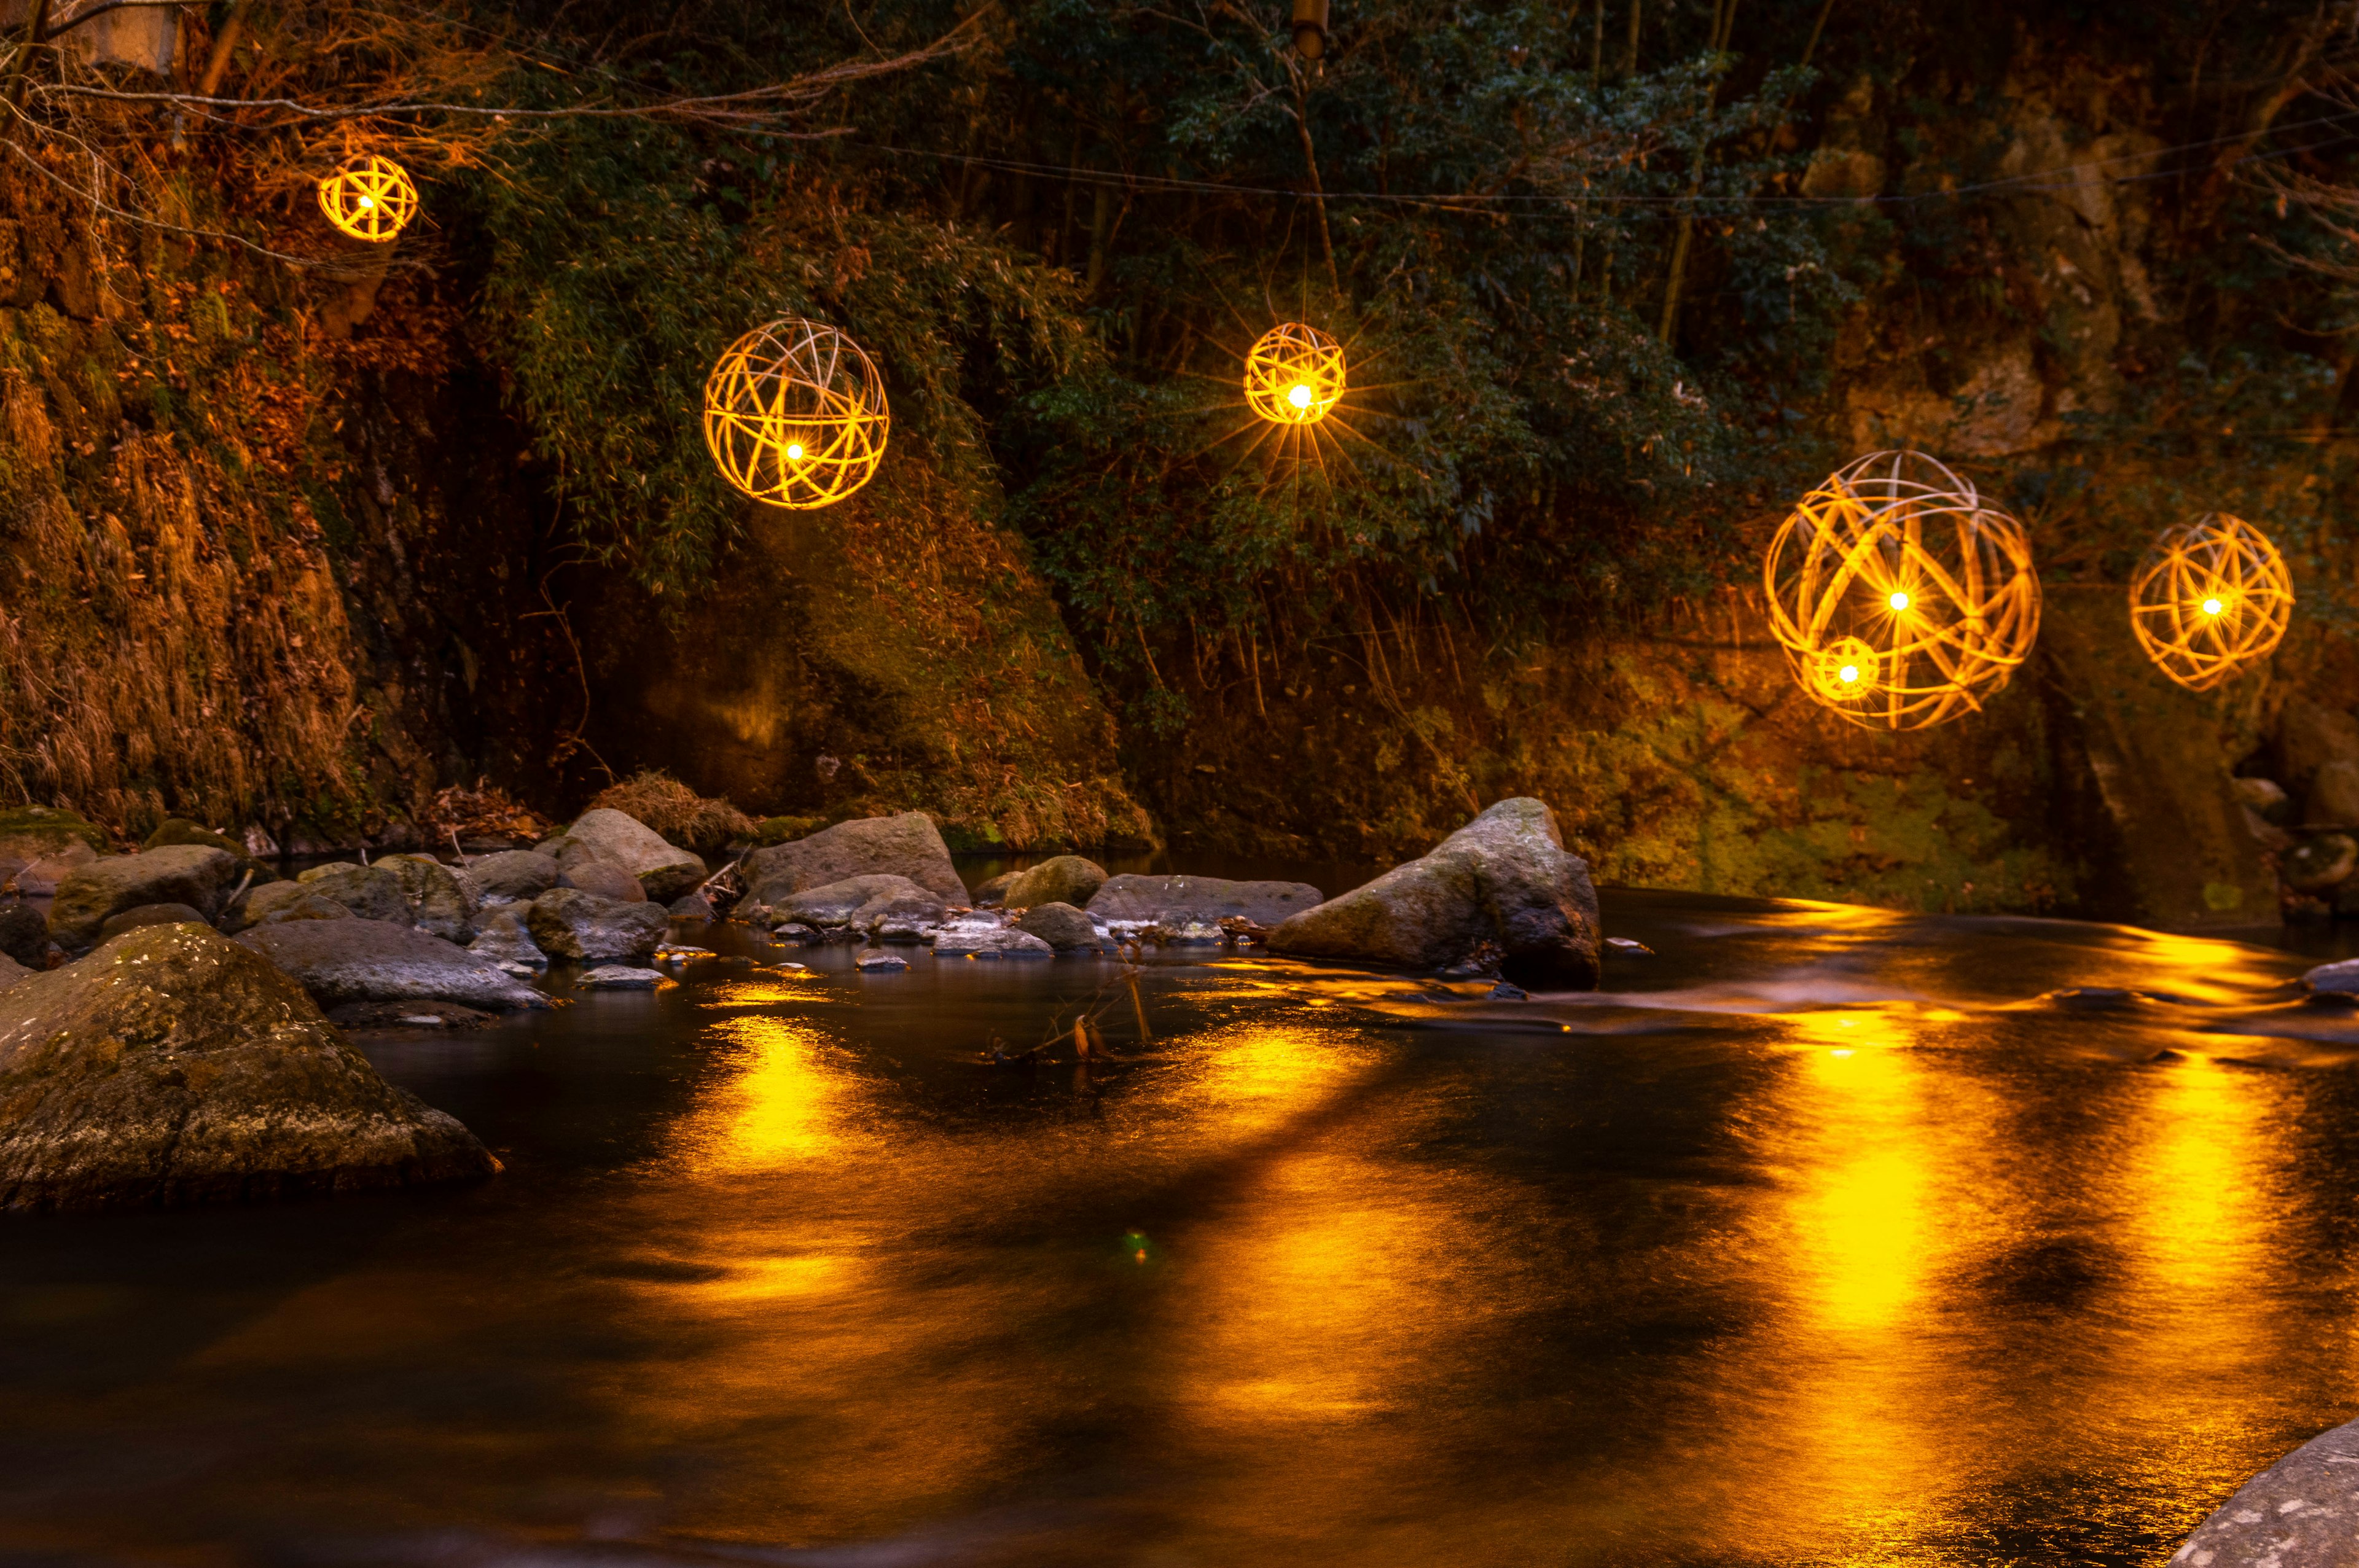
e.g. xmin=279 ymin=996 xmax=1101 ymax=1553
xmin=0 ymin=924 xmax=500 ymax=1209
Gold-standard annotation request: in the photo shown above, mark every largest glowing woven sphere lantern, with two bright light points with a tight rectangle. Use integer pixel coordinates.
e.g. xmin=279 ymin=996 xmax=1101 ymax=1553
xmin=1762 ymin=453 xmax=2041 ymax=728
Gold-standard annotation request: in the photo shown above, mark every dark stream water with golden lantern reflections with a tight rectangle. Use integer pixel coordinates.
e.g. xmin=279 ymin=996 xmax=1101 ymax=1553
xmin=0 ymin=891 xmax=2359 ymax=1568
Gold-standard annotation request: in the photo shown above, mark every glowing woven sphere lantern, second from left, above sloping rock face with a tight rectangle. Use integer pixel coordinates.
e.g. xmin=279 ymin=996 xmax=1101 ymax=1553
xmin=705 ymin=316 xmax=892 ymax=512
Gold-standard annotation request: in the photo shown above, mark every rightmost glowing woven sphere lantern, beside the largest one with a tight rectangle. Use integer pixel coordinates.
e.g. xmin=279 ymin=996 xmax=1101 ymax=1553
xmin=2130 ymin=512 xmax=2293 ymax=691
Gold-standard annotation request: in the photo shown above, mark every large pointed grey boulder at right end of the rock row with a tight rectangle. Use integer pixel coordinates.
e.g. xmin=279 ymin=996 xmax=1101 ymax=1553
xmin=1269 ymin=797 xmax=1597 ymax=990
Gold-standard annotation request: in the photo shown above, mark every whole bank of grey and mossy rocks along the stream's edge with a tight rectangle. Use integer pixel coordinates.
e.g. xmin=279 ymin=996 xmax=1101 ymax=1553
xmin=0 ymin=799 xmax=1600 ymax=1207
